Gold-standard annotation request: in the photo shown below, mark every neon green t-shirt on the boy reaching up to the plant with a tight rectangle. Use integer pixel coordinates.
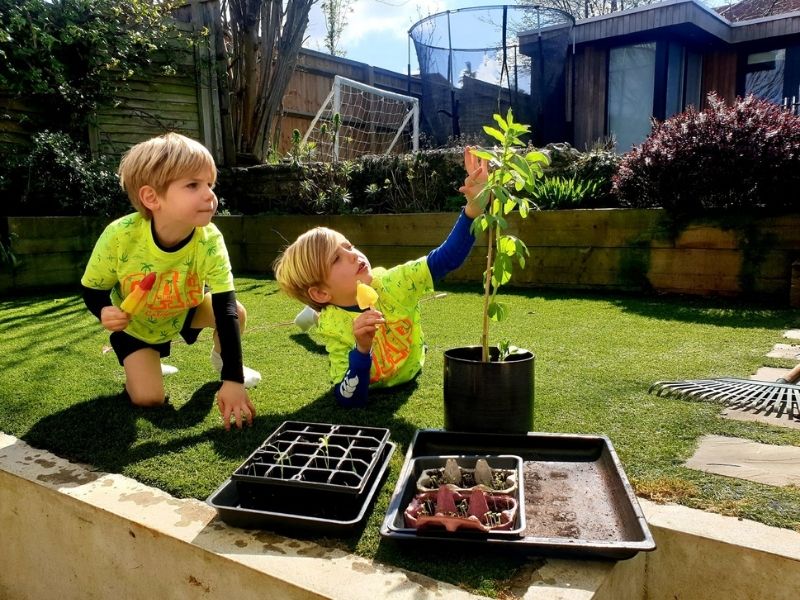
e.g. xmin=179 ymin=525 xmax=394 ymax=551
xmin=317 ymin=256 xmax=433 ymax=387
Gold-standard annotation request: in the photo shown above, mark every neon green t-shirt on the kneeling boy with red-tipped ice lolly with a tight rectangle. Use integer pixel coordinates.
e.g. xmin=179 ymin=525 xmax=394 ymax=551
xmin=81 ymin=213 xmax=234 ymax=344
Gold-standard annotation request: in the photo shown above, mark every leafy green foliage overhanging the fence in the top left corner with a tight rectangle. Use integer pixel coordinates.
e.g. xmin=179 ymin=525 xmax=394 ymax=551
xmin=0 ymin=0 xmax=181 ymax=129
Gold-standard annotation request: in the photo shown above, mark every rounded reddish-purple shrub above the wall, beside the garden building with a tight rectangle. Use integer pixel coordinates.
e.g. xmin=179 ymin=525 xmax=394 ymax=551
xmin=614 ymin=94 xmax=800 ymax=219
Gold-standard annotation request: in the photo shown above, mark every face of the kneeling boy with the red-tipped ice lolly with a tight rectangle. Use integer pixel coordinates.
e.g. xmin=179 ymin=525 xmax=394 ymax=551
xmin=153 ymin=169 xmax=219 ymax=228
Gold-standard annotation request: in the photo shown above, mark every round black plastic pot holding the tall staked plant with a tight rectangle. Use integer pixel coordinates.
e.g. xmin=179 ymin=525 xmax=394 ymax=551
xmin=443 ymin=346 xmax=535 ymax=433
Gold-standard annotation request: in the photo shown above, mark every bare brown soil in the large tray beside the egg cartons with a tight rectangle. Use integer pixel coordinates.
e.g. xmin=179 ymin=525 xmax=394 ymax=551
xmin=522 ymin=461 xmax=625 ymax=541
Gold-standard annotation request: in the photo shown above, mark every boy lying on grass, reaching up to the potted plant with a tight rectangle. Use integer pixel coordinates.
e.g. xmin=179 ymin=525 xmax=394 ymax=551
xmin=274 ymin=148 xmax=488 ymax=407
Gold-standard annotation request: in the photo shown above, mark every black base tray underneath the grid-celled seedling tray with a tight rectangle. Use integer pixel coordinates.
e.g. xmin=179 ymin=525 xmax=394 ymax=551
xmin=206 ymin=442 xmax=395 ymax=536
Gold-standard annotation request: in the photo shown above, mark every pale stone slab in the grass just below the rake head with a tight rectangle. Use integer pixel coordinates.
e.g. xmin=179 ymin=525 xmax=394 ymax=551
xmin=685 ymin=435 xmax=800 ymax=486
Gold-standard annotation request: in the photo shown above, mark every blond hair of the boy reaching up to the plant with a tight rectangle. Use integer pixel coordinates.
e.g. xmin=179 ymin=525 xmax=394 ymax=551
xmin=272 ymin=227 xmax=345 ymax=310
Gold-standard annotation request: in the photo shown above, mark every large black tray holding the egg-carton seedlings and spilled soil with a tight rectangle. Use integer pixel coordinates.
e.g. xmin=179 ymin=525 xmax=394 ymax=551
xmin=380 ymin=429 xmax=655 ymax=560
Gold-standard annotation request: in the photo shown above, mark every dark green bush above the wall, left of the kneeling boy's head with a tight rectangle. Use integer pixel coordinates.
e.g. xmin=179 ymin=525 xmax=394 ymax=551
xmin=0 ymin=131 xmax=131 ymax=217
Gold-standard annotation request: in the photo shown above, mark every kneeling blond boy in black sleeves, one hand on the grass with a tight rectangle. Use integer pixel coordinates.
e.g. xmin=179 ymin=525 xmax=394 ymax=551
xmin=81 ymin=133 xmax=261 ymax=429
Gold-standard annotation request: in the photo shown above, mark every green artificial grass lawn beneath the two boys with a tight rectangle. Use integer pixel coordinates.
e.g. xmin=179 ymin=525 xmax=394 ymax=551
xmin=0 ymin=278 xmax=800 ymax=596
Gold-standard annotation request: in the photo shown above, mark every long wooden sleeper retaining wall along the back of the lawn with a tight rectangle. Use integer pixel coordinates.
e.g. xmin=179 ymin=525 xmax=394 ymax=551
xmin=0 ymin=209 xmax=800 ymax=304
